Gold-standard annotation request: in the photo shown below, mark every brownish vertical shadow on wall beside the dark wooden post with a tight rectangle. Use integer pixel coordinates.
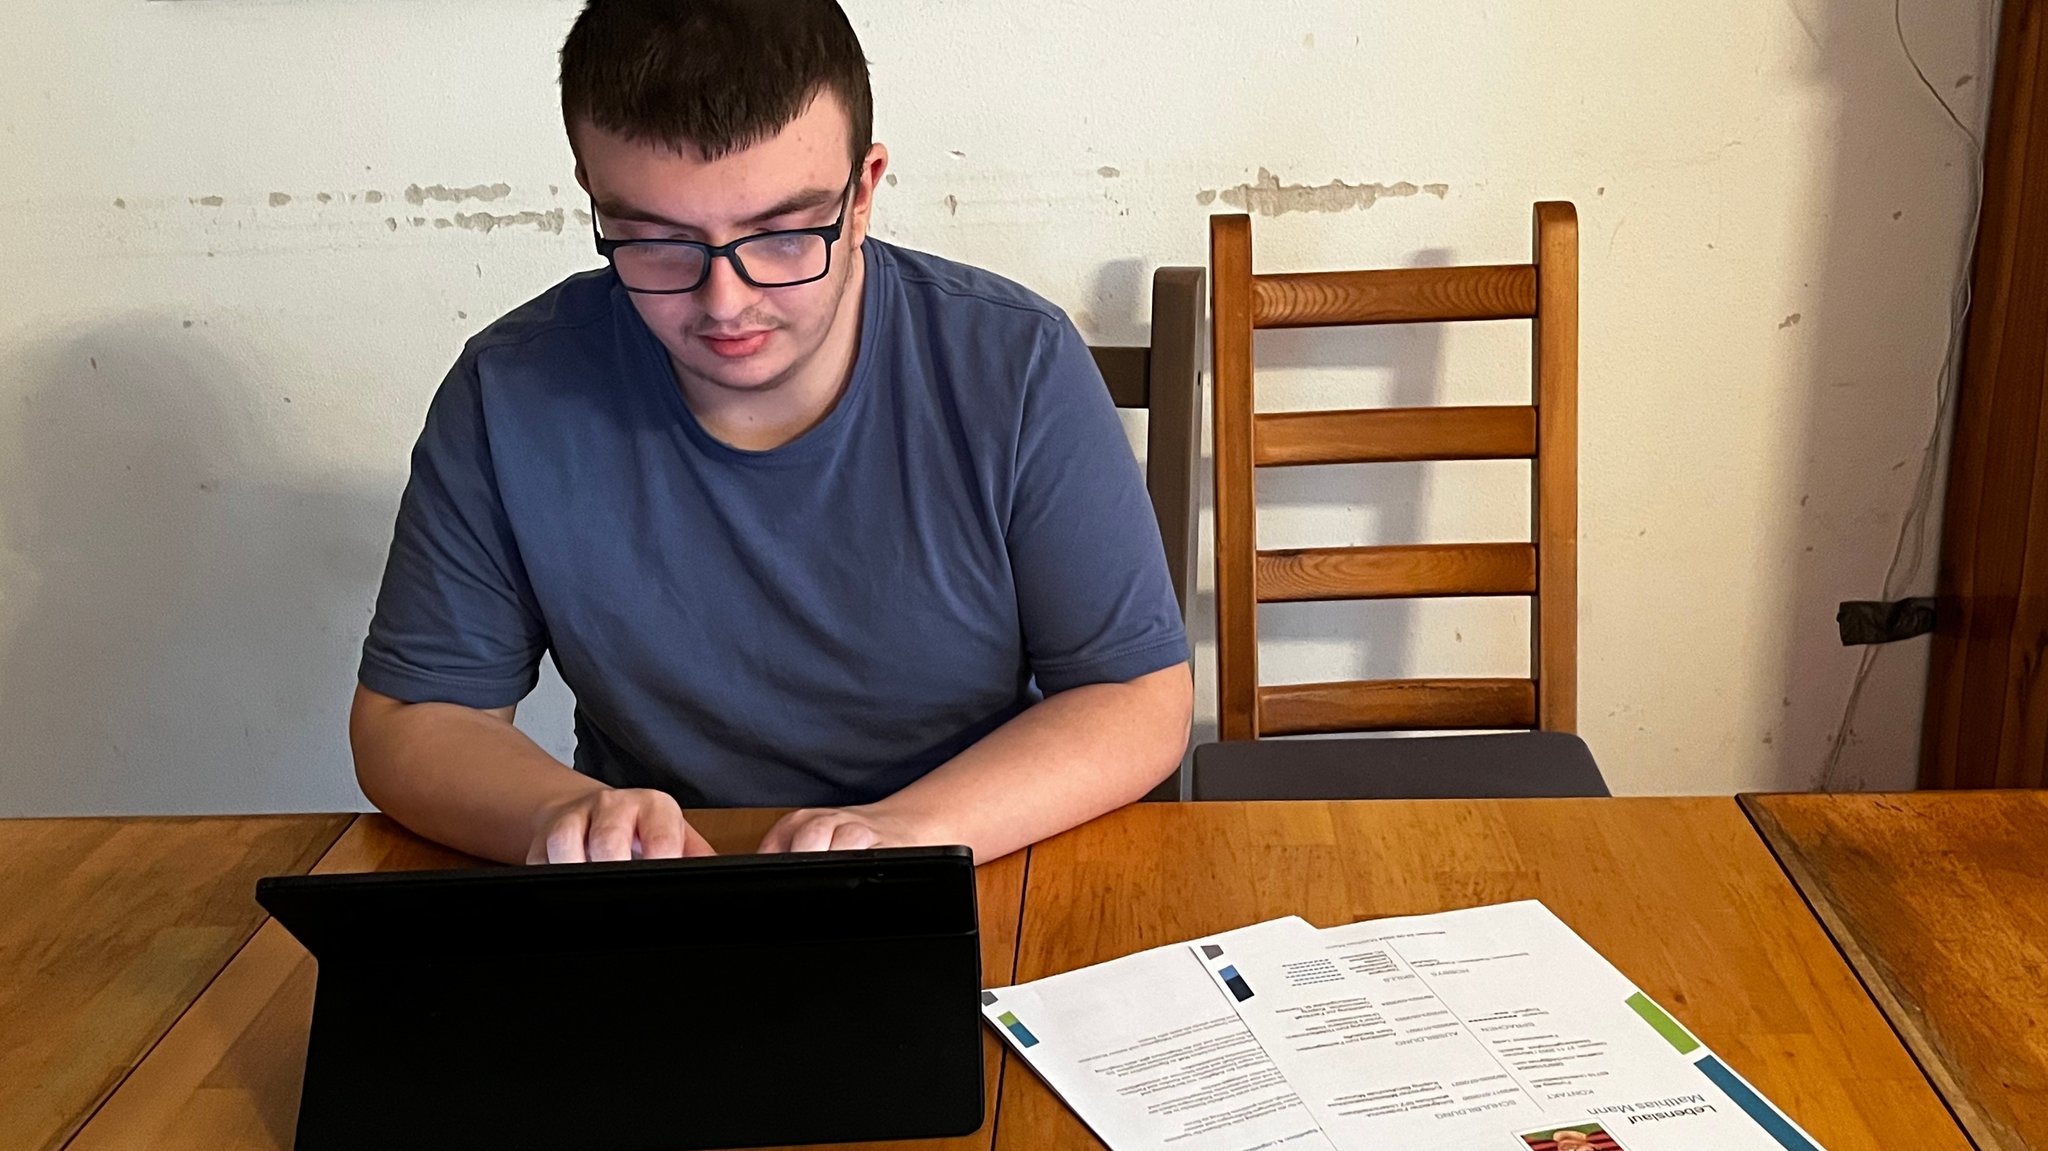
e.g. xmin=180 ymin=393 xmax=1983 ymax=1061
xmin=1769 ymin=0 xmax=1997 ymax=791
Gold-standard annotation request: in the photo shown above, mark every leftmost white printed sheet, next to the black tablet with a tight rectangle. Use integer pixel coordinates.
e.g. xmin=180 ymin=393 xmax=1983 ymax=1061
xmin=981 ymin=918 xmax=1329 ymax=1151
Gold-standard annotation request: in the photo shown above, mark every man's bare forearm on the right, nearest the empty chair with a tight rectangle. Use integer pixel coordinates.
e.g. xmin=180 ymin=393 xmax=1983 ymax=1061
xmin=872 ymin=664 xmax=1194 ymax=862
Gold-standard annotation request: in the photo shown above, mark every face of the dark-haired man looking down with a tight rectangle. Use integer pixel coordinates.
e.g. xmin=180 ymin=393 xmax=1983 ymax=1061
xmin=571 ymin=92 xmax=889 ymax=393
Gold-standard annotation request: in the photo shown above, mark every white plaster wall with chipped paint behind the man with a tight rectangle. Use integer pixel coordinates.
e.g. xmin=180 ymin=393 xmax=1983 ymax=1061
xmin=0 ymin=0 xmax=1987 ymax=815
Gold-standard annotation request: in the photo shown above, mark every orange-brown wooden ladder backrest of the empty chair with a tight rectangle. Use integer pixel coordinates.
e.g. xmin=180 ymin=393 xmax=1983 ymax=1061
xmin=1208 ymin=203 xmax=1579 ymax=739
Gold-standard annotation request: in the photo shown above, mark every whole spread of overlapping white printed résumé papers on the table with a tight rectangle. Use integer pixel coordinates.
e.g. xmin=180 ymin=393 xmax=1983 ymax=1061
xmin=981 ymin=901 xmax=1819 ymax=1151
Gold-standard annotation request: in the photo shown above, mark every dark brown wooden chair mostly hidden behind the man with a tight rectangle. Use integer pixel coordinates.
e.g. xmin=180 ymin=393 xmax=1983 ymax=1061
xmin=1090 ymin=268 xmax=1208 ymax=799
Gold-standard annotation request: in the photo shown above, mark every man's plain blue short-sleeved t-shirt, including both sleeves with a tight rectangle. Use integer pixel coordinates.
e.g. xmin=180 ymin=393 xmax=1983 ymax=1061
xmin=358 ymin=238 xmax=1188 ymax=805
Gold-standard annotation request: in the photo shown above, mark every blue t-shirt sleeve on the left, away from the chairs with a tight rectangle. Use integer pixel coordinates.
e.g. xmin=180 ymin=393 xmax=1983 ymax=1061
xmin=356 ymin=354 xmax=547 ymax=709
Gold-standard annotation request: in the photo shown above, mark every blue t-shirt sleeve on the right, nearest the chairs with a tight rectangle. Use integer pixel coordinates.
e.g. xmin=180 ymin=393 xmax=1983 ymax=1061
xmin=1008 ymin=317 xmax=1188 ymax=694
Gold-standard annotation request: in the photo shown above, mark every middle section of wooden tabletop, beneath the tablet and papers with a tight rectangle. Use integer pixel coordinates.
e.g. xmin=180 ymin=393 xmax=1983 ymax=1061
xmin=0 ymin=799 xmax=1968 ymax=1151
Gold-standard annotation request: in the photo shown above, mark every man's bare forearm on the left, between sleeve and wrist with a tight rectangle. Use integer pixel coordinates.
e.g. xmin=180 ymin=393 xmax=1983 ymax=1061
xmin=348 ymin=688 xmax=604 ymax=862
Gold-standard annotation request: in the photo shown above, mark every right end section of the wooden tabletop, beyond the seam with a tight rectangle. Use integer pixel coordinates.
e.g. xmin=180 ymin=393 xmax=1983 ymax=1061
xmin=1743 ymin=791 xmax=2048 ymax=1151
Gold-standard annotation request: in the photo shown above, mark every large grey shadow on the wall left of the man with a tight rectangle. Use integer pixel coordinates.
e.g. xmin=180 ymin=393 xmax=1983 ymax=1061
xmin=0 ymin=315 xmax=393 ymax=815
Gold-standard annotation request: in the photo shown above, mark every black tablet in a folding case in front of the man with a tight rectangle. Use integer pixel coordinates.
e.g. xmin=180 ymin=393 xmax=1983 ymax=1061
xmin=256 ymin=848 xmax=983 ymax=1151
